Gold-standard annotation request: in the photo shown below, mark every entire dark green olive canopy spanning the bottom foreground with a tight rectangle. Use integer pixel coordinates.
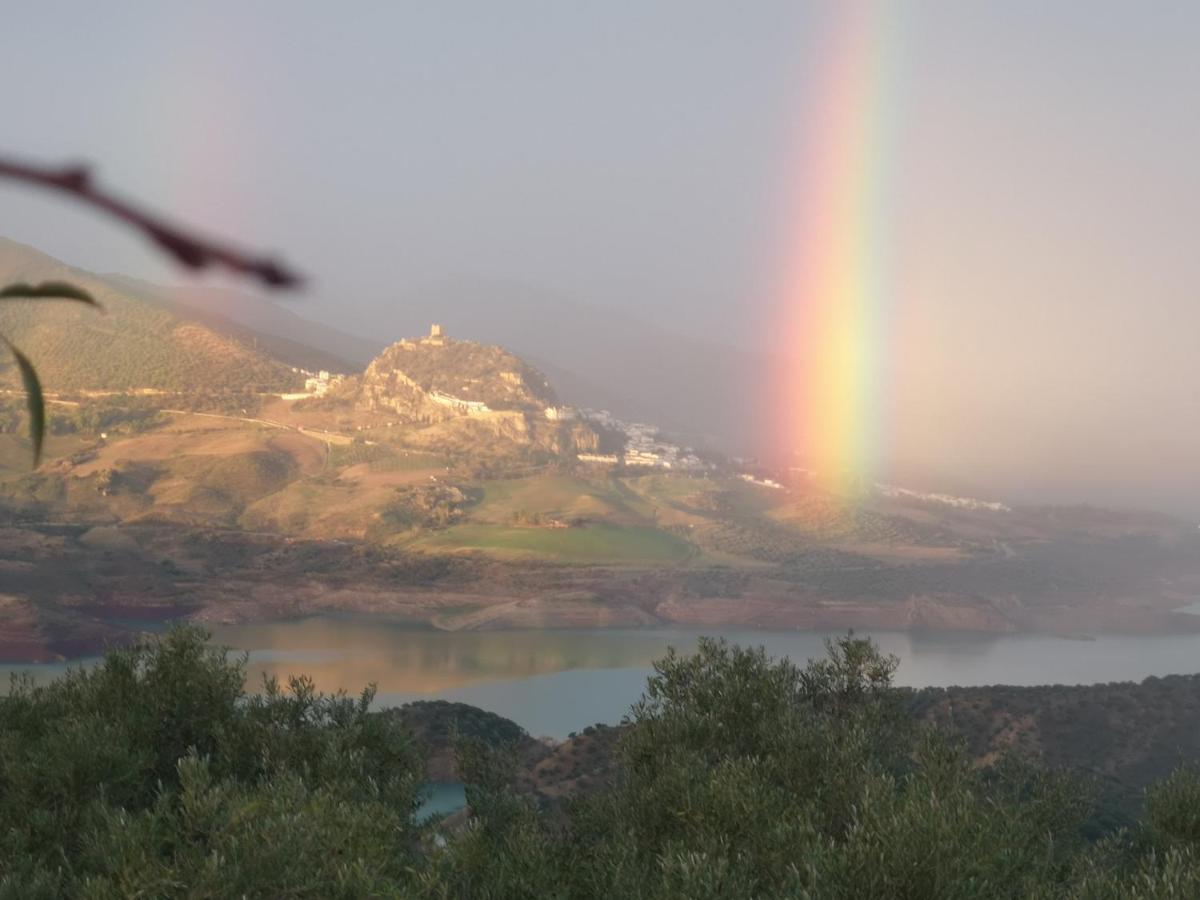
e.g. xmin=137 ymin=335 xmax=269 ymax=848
xmin=0 ymin=628 xmax=1200 ymax=898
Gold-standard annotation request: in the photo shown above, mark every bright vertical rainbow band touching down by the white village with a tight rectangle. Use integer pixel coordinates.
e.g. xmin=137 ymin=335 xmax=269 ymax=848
xmin=779 ymin=0 xmax=890 ymax=488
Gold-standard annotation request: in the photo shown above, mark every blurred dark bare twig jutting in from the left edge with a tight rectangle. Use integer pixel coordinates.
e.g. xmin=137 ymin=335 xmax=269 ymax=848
xmin=0 ymin=157 xmax=301 ymax=288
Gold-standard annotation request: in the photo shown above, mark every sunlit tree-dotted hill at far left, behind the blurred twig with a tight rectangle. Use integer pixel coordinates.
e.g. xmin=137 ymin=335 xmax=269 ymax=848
xmin=0 ymin=238 xmax=362 ymax=391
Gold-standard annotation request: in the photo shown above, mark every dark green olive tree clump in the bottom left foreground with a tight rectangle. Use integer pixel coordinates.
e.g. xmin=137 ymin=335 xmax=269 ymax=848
xmin=0 ymin=628 xmax=421 ymax=898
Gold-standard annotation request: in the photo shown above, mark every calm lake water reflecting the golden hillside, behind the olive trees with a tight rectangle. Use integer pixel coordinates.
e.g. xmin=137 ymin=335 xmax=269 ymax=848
xmin=9 ymin=617 xmax=1200 ymax=738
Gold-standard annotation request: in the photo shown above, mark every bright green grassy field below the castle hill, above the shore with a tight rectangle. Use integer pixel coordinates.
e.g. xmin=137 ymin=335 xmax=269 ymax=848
xmin=414 ymin=523 xmax=696 ymax=563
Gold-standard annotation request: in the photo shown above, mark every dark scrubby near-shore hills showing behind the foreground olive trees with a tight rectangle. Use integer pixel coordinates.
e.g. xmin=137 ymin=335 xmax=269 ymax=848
xmin=405 ymin=674 xmax=1200 ymax=836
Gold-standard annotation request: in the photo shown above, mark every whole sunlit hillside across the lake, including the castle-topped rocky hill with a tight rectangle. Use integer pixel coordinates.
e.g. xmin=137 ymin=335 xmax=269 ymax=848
xmin=0 ymin=234 xmax=1200 ymax=634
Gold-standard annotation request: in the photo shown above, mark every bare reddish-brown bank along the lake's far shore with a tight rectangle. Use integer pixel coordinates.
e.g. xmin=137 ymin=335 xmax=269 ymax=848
xmin=0 ymin=526 xmax=1200 ymax=662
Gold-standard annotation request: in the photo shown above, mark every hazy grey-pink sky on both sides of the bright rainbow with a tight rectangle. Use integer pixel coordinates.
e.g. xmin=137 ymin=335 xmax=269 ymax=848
xmin=0 ymin=0 xmax=1200 ymax=514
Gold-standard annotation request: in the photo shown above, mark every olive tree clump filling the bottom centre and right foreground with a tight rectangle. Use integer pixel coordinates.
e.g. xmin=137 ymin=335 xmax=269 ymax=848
xmin=419 ymin=636 xmax=1200 ymax=900
